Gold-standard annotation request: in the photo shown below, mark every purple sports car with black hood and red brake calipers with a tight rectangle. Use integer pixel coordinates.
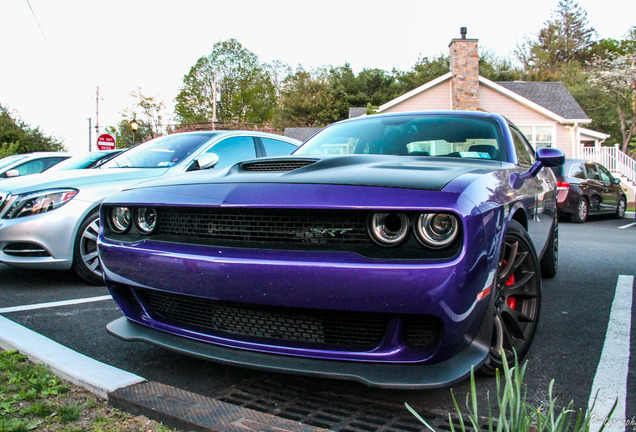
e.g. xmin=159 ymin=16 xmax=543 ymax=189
xmin=99 ymin=111 xmax=564 ymax=389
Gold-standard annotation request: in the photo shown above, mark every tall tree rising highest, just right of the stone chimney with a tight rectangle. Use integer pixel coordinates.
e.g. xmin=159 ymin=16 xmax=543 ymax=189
xmin=515 ymin=0 xmax=596 ymax=81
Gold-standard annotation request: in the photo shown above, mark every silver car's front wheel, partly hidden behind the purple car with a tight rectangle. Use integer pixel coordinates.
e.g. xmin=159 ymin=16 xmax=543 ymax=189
xmin=73 ymin=209 xmax=104 ymax=285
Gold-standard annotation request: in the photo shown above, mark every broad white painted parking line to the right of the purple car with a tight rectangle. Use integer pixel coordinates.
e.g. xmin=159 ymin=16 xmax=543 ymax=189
xmin=588 ymin=275 xmax=634 ymax=432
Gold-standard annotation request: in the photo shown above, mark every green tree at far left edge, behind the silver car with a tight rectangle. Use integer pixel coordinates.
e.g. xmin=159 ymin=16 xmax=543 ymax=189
xmin=0 ymin=105 xmax=65 ymax=157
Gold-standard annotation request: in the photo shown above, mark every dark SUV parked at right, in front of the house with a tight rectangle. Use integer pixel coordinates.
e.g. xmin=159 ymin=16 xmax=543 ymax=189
xmin=552 ymin=159 xmax=627 ymax=223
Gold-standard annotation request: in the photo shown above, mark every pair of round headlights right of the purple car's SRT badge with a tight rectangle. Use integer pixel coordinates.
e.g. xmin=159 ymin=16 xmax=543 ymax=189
xmin=369 ymin=213 xmax=459 ymax=249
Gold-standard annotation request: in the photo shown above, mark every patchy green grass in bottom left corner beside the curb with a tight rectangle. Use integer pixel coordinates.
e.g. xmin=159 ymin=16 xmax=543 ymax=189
xmin=0 ymin=351 xmax=176 ymax=432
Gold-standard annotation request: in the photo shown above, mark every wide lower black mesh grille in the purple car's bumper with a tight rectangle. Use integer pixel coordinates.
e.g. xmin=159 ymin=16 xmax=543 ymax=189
xmin=136 ymin=290 xmax=388 ymax=349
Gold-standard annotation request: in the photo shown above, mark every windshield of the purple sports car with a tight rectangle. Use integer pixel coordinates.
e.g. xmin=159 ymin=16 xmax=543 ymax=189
xmin=294 ymin=114 xmax=507 ymax=161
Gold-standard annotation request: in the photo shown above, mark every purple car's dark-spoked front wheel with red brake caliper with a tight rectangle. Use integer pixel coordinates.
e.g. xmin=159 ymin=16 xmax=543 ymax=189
xmin=482 ymin=220 xmax=541 ymax=374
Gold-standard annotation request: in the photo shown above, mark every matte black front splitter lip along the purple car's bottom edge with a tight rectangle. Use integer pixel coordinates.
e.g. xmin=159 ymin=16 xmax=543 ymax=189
xmin=106 ymin=317 xmax=488 ymax=390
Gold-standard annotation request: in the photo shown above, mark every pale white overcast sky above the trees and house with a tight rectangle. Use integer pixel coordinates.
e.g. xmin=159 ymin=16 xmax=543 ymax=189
xmin=0 ymin=0 xmax=636 ymax=153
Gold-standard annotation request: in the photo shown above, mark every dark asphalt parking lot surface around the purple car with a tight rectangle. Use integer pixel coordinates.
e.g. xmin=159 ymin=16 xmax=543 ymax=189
xmin=0 ymin=214 xmax=636 ymax=431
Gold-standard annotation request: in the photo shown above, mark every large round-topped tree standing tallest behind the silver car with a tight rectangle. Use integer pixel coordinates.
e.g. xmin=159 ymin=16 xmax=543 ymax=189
xmin=175 ymin=39 xmax=276 ymax=124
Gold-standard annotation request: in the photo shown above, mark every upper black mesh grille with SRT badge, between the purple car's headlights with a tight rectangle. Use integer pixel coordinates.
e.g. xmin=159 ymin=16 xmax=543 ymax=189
xmin=157 ymin=208 xmax=371 ymax=245
